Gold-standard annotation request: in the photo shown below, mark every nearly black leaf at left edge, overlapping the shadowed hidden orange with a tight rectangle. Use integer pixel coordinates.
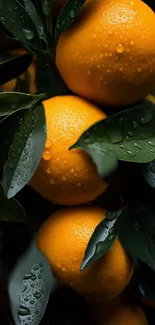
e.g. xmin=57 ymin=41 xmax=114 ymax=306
xmin=0 ymin=54 xmax=32 ymax=84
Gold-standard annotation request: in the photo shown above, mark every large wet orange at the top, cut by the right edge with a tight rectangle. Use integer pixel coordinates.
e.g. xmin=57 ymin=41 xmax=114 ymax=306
xmin=56 ymin=0 xmax=155 ymax=106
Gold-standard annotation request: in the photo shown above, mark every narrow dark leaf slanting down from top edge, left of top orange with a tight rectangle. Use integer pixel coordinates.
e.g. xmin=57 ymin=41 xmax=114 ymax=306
xmin=22 ymin=0 xmax=47 ymax=43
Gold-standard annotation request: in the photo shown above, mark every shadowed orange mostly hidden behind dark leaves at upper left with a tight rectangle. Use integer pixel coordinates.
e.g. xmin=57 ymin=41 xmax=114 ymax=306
xmin=0 ymin=48 xmax=37 ymax=94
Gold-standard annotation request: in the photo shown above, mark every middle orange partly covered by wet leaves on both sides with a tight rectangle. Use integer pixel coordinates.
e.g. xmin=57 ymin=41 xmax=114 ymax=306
xmin=31 ymin=96 xmax=107 ymax=205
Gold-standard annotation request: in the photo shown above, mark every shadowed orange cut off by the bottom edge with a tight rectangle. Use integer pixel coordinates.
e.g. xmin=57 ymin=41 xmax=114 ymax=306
xmin=93 ymin=297 xmax=148 ymax=325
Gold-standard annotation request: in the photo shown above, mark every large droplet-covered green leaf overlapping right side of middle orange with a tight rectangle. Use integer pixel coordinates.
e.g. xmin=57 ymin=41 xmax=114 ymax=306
xmin=71 ymin=100 xmax=155 ymax=177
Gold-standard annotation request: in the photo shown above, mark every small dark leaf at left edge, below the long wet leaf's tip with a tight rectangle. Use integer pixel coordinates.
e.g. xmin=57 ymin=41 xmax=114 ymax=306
xmin=0 ymin=199 xmax=27 ymax=222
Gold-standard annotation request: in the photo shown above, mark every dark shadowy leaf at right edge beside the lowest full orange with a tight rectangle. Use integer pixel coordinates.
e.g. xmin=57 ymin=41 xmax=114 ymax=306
xmin=119 ymin=204 xmax=155 ymax=270
